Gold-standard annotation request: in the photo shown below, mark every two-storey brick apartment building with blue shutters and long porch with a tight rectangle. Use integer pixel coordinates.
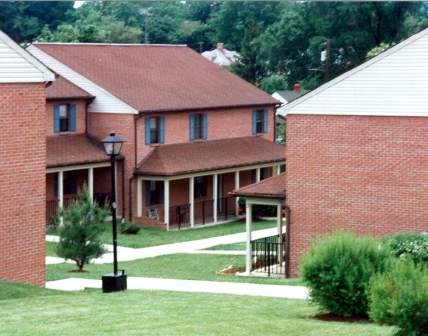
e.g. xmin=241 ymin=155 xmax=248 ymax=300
xmin=27 ymin=44 xmax=285 ymax=228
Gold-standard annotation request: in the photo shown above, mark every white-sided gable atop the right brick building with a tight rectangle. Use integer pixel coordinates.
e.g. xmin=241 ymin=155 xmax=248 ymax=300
xmin=282 ymin=29 xmax=428 ymax=117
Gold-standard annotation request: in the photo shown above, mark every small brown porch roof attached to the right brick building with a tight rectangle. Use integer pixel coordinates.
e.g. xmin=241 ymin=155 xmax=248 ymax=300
xmin=231 ymin=173 xmax=287 ymax=199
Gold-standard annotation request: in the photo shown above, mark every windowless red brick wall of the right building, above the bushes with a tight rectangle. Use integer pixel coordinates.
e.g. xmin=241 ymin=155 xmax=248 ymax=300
xmin=286 ymin=115 xmax=428 ymax=276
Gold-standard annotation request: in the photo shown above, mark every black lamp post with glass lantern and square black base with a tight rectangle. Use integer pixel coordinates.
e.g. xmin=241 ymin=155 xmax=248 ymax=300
xmin=102 ymin=133 xmax=127 ymax=293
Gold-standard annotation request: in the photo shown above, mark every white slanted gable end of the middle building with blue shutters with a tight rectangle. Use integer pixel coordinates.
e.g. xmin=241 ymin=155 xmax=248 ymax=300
xmin=27 ymin=45 xmax=138 ymax=114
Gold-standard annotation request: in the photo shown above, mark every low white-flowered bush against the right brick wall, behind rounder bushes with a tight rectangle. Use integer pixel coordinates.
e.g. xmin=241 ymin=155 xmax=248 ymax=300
xmin=385 ymin=233 xmax=428 ymax=265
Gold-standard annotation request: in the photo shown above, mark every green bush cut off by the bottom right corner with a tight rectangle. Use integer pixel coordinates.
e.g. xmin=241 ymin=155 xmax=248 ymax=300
xmin=368 ymin=260 xmax=428 ymax=336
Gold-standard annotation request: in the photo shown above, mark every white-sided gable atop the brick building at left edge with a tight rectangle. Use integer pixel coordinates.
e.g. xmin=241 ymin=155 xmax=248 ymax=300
xmin=0 ymin=31 xmax=55 ymax=83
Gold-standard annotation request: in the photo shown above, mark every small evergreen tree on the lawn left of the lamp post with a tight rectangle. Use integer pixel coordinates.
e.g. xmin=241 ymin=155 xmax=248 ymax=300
xmin=56 ymin=188 xmax=108 ymax=271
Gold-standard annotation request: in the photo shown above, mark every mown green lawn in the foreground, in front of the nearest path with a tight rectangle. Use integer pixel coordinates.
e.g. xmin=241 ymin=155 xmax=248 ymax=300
xmin=0 ymin=283 xmax=394 ymax=336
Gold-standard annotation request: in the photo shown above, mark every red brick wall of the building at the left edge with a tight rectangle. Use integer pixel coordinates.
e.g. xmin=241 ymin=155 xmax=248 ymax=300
xmin=0 ymin=84 xmax=46 ymax=285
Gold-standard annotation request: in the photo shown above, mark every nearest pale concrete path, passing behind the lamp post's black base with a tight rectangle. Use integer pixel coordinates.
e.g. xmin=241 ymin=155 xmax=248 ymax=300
xmin=46 ymin=277 xmax=309 ymax=300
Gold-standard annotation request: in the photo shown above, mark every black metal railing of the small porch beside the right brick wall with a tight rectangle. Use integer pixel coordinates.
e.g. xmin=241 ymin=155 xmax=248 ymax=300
xmin=251 ymin=233 xmax=287 ymax=277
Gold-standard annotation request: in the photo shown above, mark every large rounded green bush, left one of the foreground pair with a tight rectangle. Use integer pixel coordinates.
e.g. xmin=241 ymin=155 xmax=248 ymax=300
xmin=301 ymin=233 xmax=392 ymax=317
